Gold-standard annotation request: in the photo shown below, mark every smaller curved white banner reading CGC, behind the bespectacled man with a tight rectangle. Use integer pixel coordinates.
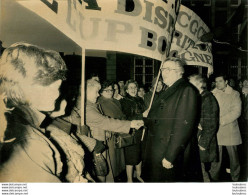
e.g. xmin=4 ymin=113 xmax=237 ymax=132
xmin=170 ymin=5 xmax=213 ymax=74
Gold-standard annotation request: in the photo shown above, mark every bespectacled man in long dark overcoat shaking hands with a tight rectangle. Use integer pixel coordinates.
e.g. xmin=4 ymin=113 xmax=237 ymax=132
xmin=142 ymin=57 xmax=202 ymax=182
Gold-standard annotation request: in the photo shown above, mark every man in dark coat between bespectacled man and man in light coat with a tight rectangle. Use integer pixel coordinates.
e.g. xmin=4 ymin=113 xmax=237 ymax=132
xmin=189 ymin=74 xmax=219 ymax=182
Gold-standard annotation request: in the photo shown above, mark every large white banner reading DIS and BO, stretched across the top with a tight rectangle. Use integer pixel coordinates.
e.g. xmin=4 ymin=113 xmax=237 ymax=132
xmin=17 ymin=0 xmax=179 ymax=60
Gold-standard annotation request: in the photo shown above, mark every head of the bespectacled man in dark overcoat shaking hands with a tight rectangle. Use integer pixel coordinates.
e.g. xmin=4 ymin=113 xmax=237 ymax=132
xmin=160 ymin=61 xmax=182 ymax=86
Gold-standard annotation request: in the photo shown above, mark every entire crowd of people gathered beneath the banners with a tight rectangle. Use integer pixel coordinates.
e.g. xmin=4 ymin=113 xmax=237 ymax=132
xmin=0 ymin=43 xmax=248 ymax=183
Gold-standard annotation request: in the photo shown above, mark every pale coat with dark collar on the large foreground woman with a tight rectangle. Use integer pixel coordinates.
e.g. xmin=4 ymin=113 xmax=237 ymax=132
xmin=0 ymin=106 xmax=75 ymax=182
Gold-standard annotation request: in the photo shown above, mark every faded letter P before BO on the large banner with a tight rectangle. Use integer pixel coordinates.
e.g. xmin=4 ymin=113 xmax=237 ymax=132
xmin=105 ymin=20 xmax=133 ymax=42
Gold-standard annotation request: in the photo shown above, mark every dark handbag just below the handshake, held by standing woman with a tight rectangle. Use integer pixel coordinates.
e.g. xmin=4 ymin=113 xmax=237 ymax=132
xmin=114 ymin=133 xmax=136 ymax=148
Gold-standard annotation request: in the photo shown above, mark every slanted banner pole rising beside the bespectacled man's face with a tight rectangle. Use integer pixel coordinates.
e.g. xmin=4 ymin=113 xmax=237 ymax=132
xmin=147 ymin=0 xmax=181 ymax=112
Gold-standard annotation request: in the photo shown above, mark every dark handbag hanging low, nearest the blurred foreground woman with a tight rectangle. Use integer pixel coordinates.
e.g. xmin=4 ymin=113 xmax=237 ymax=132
xmin=93 ymin=152 xmax=109 ymax=176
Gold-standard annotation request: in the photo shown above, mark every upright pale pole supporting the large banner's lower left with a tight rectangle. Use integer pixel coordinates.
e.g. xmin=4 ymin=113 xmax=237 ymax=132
xmin=80 ymin=47 xmax=86 ymax=126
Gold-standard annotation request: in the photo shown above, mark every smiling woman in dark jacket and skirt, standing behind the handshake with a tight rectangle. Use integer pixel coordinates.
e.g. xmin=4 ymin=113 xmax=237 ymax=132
xmin=120 ymin=80 xmax=145 ymax=182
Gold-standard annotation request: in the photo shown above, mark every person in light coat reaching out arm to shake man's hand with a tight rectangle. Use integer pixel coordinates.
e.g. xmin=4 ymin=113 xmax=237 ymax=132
xmin=86 ymin=79 xmax=144 ymax=182
